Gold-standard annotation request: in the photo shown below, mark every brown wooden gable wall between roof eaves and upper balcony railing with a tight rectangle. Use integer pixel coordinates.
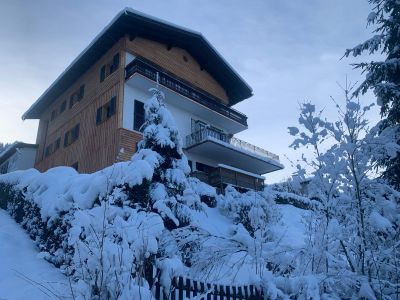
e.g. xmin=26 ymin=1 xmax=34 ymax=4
xmin=126 ymin=37 xmax=229 ymax=104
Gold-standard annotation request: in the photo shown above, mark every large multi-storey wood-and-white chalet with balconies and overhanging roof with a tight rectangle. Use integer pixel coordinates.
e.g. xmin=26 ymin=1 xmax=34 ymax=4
xmin=23 ymin=9 xmax=283 ymax=189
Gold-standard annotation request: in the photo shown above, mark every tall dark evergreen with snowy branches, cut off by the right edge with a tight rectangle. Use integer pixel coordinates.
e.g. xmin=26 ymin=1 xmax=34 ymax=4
xmin=345 ymin=0 xmax=400 ymax=189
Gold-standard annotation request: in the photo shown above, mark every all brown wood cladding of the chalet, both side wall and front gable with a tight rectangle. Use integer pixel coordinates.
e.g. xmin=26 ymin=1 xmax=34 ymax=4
xmin=35 ymin=36 xmax=228 ymax=173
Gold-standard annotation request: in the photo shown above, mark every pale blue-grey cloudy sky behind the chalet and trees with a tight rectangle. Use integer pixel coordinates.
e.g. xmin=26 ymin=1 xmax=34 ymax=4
xmin=0 ymin=0 xmax=378 ymax=182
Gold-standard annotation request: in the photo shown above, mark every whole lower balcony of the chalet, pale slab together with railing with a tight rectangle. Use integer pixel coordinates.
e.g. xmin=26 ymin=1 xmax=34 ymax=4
xmin=185 ymin=128 xmax=283 ymax=176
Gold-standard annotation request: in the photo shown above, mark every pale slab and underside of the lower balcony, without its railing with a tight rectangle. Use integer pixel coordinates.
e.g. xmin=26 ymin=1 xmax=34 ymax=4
xmin=185 ymin=137 xmax=284 ymax=175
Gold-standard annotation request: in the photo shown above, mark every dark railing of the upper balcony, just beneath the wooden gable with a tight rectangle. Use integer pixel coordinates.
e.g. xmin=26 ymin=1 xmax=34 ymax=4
xmin=126 ymin=58 xmax=247 ymax=126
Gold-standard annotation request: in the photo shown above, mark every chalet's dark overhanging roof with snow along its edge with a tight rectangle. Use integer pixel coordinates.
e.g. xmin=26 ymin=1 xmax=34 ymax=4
xmin=22 ymin=8 xmax=252 ymax=119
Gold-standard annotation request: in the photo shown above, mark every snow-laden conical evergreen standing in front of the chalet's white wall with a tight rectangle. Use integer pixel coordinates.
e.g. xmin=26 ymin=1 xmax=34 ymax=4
xmin=132 ymin=88 xmax=201 ymax=230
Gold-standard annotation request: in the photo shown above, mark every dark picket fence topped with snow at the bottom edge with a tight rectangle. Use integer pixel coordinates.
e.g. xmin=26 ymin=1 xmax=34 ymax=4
xmin=152 ymin=272 xmax=264 ymax=300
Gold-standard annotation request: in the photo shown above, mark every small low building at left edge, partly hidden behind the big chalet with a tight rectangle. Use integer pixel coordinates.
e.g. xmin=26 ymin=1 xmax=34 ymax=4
xmin=0 ymin=142 xmax=37 ymax=174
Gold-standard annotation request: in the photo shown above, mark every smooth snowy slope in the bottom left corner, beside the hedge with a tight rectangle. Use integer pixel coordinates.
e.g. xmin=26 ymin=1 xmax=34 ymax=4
xmin=0 ymin=209 xmax=72 ymax=300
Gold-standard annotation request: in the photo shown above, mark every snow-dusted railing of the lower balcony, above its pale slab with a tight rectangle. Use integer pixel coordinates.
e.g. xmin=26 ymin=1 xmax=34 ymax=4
xmin=186 ymin=128 xmax=279 ymax=161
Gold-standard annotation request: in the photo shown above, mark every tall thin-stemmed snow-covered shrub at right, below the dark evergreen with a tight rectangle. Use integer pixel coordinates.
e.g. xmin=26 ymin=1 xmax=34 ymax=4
xmin=289 ymin=90 xmax=400 ymax=299
